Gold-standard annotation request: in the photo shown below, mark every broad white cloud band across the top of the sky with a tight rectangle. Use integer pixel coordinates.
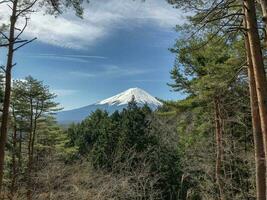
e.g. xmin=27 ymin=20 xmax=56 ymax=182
xmin=0 ymin=0 xmax=184 ymax=49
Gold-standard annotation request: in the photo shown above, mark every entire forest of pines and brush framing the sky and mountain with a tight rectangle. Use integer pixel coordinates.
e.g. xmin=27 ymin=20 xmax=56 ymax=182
xmin=0 ymin=0 xmax=267 ymax=200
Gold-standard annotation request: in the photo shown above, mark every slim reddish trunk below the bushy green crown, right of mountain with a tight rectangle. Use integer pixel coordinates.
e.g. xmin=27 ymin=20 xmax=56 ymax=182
xmin=214 ymin=96 xmax=224 ymax=200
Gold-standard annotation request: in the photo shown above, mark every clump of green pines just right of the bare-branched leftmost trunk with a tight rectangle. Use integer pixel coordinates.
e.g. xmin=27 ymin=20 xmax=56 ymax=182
xmin=6 ymin=76 xmax=62 ymax=196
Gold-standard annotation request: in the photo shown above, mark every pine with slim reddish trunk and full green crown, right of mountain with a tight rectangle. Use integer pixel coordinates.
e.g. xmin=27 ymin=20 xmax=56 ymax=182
xmin=169 ymin=35 xmax=247 ymax=199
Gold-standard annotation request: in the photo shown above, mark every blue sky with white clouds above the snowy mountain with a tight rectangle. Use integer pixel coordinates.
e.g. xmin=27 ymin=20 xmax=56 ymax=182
xmin=0 ymin=0 xmax=188 ymax=110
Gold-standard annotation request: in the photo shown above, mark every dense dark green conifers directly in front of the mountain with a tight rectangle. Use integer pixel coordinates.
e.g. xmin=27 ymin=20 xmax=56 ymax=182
xmin=67 ymin=101 xmax=156 ymax=168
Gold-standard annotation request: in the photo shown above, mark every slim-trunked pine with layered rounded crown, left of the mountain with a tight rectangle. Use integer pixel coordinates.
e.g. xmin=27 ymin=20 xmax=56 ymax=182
xmin=12 ymin=76 xmax=58 ymax=199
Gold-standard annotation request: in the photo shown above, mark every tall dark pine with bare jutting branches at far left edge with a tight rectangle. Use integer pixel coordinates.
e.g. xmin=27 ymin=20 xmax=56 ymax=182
xmin=0 ymin=0 xmax=83 ymax=193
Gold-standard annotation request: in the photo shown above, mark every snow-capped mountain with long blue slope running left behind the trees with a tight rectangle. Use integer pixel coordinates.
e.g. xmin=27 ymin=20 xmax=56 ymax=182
xmin=56 ymin=88 xmax=162 ymax=124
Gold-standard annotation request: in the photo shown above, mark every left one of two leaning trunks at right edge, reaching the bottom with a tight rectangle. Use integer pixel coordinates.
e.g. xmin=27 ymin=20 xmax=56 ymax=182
xmin=245 ymin=28 xmax=266 ymax=200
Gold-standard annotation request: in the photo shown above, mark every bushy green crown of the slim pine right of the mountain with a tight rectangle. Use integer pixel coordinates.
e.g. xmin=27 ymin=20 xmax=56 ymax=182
xmin=169 ymin=35 xmax=244 ymax=100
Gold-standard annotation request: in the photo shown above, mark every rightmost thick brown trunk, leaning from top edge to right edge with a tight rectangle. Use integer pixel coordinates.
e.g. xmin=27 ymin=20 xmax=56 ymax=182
xmin=244 ymin=0 xmax=267 ymax=177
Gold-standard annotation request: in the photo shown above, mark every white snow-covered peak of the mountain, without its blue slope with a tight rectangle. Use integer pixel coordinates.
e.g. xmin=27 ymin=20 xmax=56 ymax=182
xmin=97 ymin=88 xmax=162 ymax=107
